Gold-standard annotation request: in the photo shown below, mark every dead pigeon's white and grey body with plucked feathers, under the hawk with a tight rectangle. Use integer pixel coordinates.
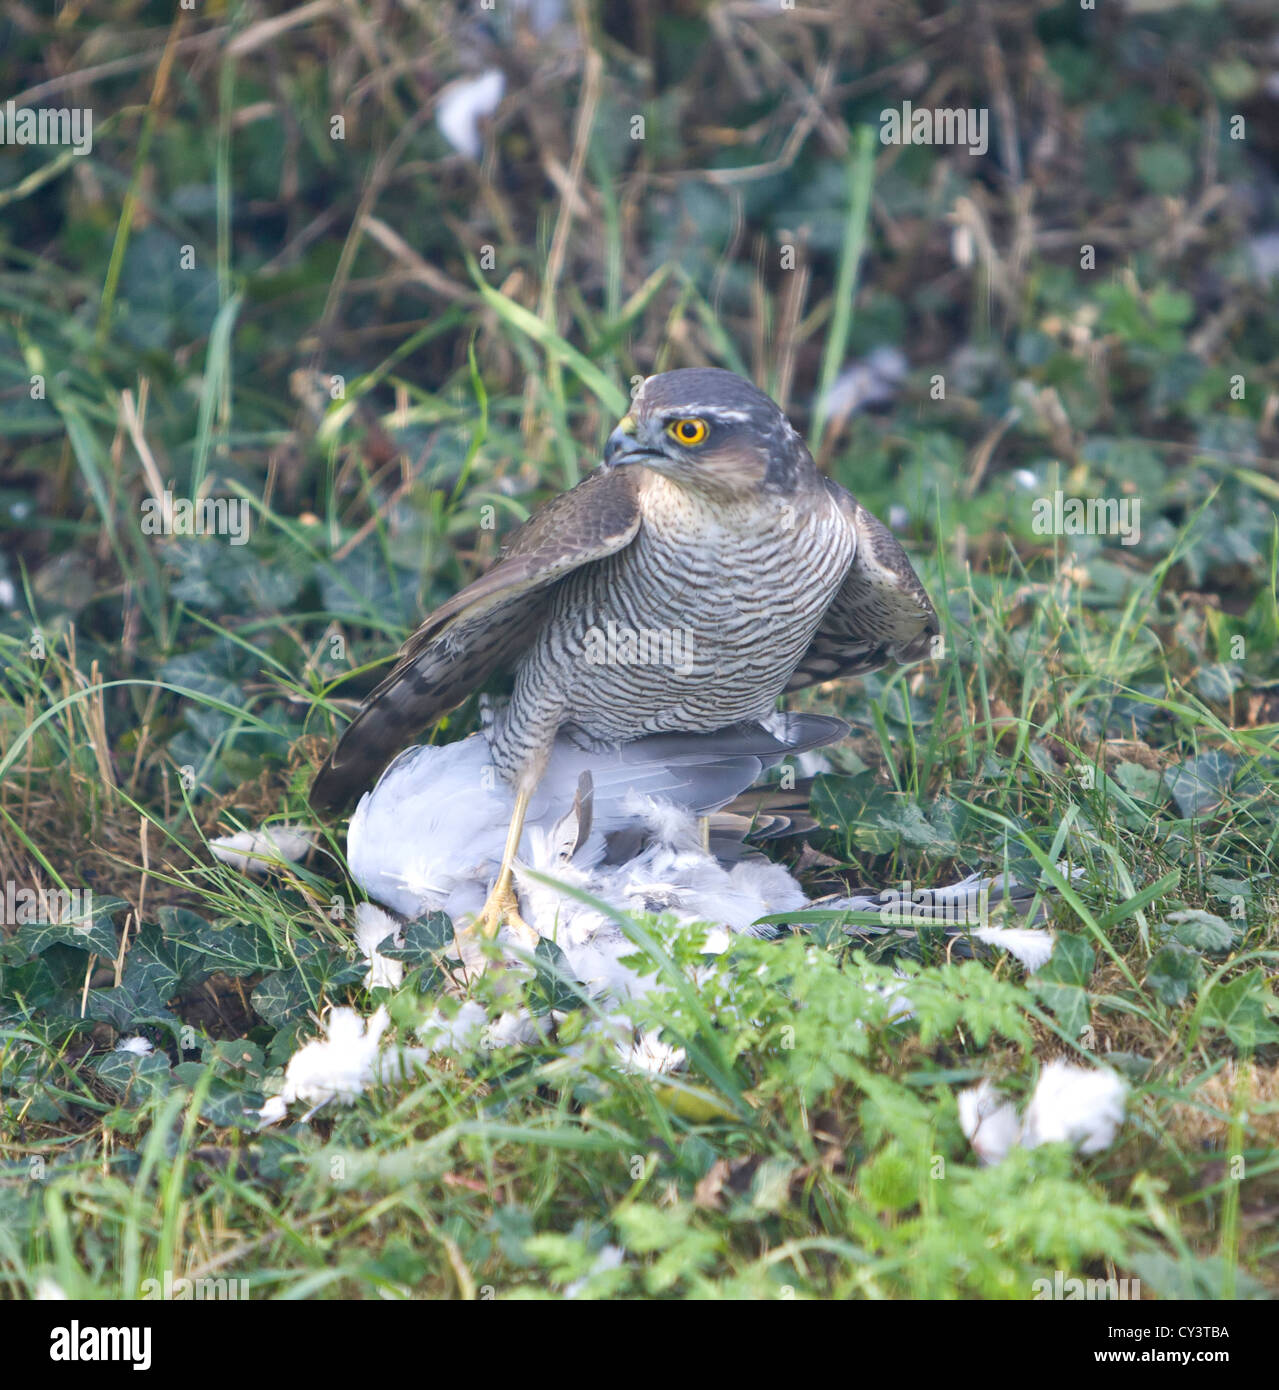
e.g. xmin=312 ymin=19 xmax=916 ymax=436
xmin=244 ymin=714 xmax=1122 ymax=1161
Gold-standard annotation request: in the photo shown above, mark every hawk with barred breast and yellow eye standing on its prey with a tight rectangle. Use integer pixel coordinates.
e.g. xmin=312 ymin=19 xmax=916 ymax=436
xmin=310 ymin=367 xmax=938 ymax=956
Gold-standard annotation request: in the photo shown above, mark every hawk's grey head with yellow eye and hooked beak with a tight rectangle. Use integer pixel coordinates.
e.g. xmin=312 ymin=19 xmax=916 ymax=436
xmin=603 ymin=367 xmax=817 ymax=495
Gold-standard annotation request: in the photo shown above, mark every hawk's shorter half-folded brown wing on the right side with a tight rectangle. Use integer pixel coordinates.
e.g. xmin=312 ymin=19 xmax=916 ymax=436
xmin=787 ymin=478 xmax=940 ymax=691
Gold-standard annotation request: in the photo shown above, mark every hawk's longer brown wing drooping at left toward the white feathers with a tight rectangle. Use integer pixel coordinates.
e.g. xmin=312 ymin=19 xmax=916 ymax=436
xmin=310 ymin=464 xmax=640 ymax=812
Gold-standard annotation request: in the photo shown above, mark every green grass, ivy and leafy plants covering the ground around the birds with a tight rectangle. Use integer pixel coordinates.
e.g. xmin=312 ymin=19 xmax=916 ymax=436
xmin=0 ymin=0 xmax=1279 ymax=1298
